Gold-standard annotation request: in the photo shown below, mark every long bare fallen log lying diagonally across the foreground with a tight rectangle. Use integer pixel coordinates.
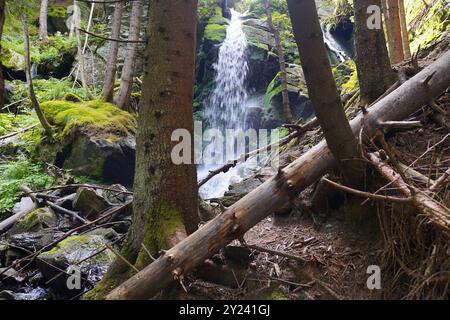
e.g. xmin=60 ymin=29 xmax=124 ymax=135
xmin=106 ymin=51 xmax=450 ymax=299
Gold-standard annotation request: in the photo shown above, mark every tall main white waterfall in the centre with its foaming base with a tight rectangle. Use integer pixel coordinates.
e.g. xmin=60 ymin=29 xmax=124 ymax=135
xmin=198 ymin=9 xmax=255 ymax=198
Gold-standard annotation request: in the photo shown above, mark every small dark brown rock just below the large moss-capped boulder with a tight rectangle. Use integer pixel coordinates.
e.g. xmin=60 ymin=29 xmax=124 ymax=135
xmin=73 ymin=187 xmax=110 ymax=220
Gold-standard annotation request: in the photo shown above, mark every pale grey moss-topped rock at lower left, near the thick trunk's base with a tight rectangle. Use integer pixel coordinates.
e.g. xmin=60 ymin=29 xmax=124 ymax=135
xmin=37 ymin=229 xmax=118 ymax=293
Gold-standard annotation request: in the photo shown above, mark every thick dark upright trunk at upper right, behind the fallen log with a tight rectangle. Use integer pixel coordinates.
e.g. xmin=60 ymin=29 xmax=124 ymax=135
xmin=354 ymin=0 xmax=395 ymax=104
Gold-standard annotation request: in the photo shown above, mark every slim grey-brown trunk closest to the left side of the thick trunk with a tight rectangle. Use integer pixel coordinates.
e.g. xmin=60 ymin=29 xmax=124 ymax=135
xmin=116 ymin=0 xmax=143 ymax=110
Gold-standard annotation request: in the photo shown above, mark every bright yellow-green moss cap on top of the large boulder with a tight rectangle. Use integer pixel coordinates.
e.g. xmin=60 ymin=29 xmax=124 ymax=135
xmin=41 ymin=100 xmax=137 ymax=140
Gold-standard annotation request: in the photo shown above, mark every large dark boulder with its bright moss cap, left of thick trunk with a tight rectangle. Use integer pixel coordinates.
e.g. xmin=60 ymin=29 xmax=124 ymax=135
xmin=37 ymin=100 xmax=137 ymax=186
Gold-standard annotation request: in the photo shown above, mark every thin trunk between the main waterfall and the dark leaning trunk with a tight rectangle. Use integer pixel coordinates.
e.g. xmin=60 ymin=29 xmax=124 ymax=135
xmin=264 ymin=0 xmax=294 ymax=123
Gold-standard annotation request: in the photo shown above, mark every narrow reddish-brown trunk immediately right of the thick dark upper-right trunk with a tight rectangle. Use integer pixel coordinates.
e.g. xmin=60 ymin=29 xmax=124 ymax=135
xmin=386 ymin=0 xmax=405 ymax=64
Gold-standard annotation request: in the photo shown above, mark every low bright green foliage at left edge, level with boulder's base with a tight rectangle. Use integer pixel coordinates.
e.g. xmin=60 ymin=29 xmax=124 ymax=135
xmin=0 ymin=156 xmax=53 ymax=216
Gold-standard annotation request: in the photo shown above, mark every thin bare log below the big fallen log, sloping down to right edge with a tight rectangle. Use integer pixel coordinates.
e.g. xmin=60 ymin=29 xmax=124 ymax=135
xmin=369 ymin=153 xmax=450 ymax=232
